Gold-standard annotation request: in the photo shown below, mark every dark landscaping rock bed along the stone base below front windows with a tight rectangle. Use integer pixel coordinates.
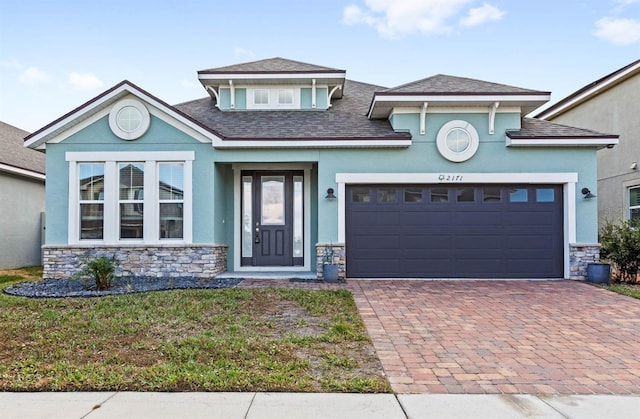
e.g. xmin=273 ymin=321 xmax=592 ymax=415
xmin=3 ymin=277 xmax=242 ymax=298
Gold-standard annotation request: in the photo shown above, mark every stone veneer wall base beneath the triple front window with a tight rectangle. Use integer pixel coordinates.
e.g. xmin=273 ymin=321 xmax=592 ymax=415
xmin=43 ymin=245 xmax=227 ymax=279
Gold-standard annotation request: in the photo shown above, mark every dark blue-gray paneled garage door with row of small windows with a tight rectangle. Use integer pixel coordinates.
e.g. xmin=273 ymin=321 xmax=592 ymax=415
xmin=346 ymin=185 xmax=563 ymax=278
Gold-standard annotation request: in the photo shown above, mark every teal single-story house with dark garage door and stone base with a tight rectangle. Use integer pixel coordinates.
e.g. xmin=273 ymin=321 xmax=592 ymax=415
xmin=26 ymin=58 xmax=618 ymax=279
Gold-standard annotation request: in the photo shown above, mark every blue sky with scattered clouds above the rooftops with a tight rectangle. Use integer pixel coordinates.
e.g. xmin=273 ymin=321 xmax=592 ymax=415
xmin=0 ymin=0 xmax=640 ymax=131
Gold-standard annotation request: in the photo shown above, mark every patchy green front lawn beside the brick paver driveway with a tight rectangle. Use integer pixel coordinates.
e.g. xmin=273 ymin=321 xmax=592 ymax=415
xmin=0 ymin=270 xmax=390 ymax=392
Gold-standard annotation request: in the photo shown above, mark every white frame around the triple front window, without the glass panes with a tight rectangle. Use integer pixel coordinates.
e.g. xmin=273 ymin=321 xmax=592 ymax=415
xmin=65 ymin=151 xmax=195 ymax=245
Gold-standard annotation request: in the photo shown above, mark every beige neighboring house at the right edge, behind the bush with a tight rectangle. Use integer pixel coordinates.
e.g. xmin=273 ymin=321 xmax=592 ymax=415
xmin=536 ymin=60 xmax=640 ymax=225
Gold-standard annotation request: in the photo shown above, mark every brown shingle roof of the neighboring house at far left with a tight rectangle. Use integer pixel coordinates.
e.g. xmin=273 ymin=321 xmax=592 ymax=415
xmin=0 ymin=122 xmax=45 ymax=174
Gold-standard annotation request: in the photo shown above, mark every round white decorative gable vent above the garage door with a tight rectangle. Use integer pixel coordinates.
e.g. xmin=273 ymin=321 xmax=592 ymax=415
xmin=436 ymin=120 xmax=480 ymax=163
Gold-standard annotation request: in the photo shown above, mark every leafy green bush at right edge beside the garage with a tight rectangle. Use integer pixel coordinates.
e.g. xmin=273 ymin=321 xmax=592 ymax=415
xmin=600 ymin=220 xmax=640 ymax=282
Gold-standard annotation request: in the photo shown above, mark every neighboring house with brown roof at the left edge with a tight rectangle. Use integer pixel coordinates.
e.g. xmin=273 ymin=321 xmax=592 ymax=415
xmin=0 ymin=122 xmax=45 ymax=269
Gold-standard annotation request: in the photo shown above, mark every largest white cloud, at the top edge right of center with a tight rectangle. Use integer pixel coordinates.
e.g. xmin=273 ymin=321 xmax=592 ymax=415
xmin=342 ymin=0 xmax=504 ymax=37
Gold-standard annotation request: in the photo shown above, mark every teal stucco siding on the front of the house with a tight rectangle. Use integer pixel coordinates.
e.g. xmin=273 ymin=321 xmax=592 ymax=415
xmin=46 ymin=106 xmax=597 ymax=270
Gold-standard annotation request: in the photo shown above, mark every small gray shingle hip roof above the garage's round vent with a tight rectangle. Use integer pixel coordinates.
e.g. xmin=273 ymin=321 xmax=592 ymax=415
xmin=378 ymin=74 xmax=549 ymax=95
